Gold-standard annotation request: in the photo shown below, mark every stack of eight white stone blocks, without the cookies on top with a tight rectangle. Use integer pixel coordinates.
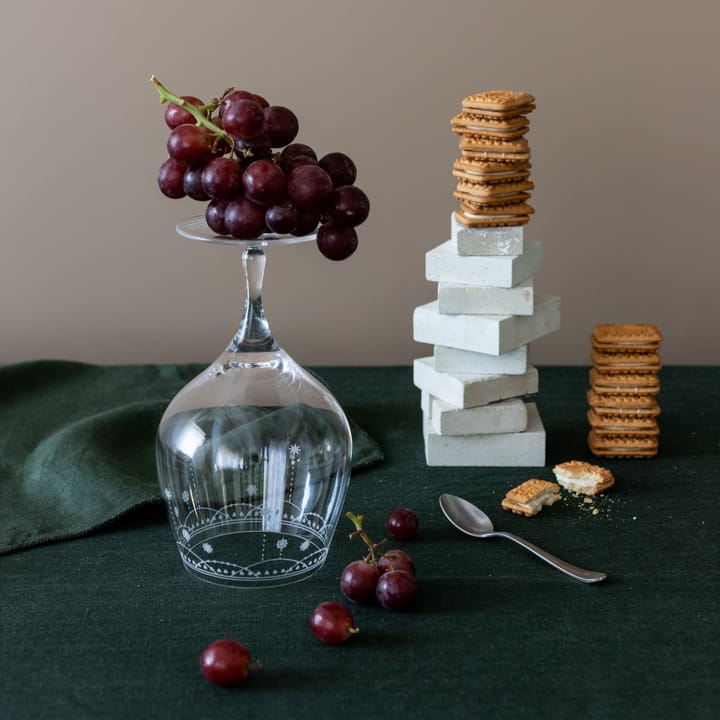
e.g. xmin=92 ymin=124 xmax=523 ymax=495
xmin=413 ymin=215 xmax=560 ymax=466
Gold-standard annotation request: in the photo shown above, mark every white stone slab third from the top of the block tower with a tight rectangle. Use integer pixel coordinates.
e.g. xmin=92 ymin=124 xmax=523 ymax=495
xmin=437 ymin=277 xmax=535 ymax=315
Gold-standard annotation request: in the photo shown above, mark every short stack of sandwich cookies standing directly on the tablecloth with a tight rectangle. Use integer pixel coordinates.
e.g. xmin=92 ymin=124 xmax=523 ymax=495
xmin=587 ymin=323 xmax=662 ymax=458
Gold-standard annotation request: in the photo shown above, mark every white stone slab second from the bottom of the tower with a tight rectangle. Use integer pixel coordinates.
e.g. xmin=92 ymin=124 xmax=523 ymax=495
xmin=422 ymin=392 xmax=527 ymax=435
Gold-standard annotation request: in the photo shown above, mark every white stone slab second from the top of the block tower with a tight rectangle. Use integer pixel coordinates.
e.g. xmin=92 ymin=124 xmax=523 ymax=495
xmin=425 ymin=240 xmax=543 ymax=288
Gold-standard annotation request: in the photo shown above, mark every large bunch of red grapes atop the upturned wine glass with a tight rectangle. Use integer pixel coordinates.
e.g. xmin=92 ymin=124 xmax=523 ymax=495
xmin=152 ymin=77 xmax=370 ymax=260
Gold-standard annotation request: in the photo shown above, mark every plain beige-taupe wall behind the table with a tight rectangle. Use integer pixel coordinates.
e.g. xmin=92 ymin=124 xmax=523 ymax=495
xmin=0 ymin=0 xmax=720 ymax=365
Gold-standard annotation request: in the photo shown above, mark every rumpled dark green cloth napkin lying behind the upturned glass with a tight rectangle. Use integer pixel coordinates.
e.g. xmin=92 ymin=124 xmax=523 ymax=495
xmin=0 ymin=360 xmax=382 ymax=555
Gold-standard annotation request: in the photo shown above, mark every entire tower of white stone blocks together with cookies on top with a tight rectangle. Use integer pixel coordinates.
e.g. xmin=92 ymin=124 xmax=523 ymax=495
xmin=413 ymin=91 xmax=560 ymax=466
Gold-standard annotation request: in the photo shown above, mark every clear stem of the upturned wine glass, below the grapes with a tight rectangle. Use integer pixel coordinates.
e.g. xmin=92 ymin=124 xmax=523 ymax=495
xmin=227 ymin=247 xmax=279 ymax=352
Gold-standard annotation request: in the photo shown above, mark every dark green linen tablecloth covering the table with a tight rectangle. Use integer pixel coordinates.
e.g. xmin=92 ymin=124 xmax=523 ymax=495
xmin=0 ymin=367 xmax=720 ymax=720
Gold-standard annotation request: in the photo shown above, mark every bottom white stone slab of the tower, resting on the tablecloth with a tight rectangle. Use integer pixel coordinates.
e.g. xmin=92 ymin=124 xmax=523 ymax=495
xmin=423 ymin=403 xmax=545 ymax=467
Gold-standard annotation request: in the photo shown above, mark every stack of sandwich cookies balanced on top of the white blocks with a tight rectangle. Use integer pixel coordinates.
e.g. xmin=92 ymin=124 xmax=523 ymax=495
xmin=450 ymin=90 xmax=535 ymax=228
